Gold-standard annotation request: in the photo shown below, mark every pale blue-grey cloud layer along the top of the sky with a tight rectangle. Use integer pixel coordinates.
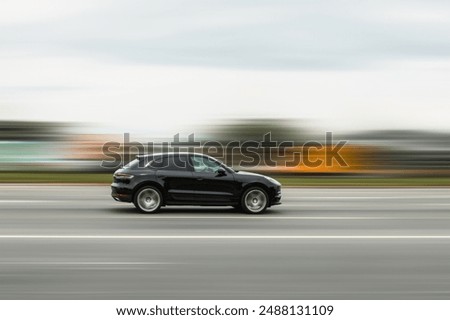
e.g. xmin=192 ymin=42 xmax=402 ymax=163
xmin=0 ymin=0 xmax=450 ymax=70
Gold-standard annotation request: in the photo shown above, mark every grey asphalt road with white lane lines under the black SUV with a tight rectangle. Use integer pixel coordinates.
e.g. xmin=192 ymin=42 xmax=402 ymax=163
xmin=0 ymin=185 xmax=450 ymax=299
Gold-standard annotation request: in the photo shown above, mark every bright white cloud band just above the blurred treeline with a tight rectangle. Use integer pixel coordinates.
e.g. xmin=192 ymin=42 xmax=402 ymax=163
xmin=0 ymin=53 xmax=450 ymax=134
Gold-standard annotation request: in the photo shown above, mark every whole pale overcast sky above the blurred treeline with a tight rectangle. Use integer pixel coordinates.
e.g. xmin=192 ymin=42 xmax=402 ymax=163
xmin=0 ymin=0 xmax=450 ymax=133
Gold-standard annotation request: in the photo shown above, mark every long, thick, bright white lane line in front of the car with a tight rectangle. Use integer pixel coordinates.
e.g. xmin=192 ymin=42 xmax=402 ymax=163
xmin=0 ymin=234 xmax=450 ymax=240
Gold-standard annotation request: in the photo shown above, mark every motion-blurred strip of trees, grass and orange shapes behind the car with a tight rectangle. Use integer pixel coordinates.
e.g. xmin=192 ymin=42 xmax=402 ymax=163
xmin=0 ymin=119 xmax=450 ymax=185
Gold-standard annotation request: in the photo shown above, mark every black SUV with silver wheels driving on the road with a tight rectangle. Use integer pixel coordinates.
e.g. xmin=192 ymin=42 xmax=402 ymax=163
xmin=111 ymin=153 xmax=281 ymax=213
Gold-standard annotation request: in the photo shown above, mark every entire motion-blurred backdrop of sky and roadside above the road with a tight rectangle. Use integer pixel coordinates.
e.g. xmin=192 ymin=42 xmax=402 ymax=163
xmin=0 ymin=0 xmax=450 ymax=185
